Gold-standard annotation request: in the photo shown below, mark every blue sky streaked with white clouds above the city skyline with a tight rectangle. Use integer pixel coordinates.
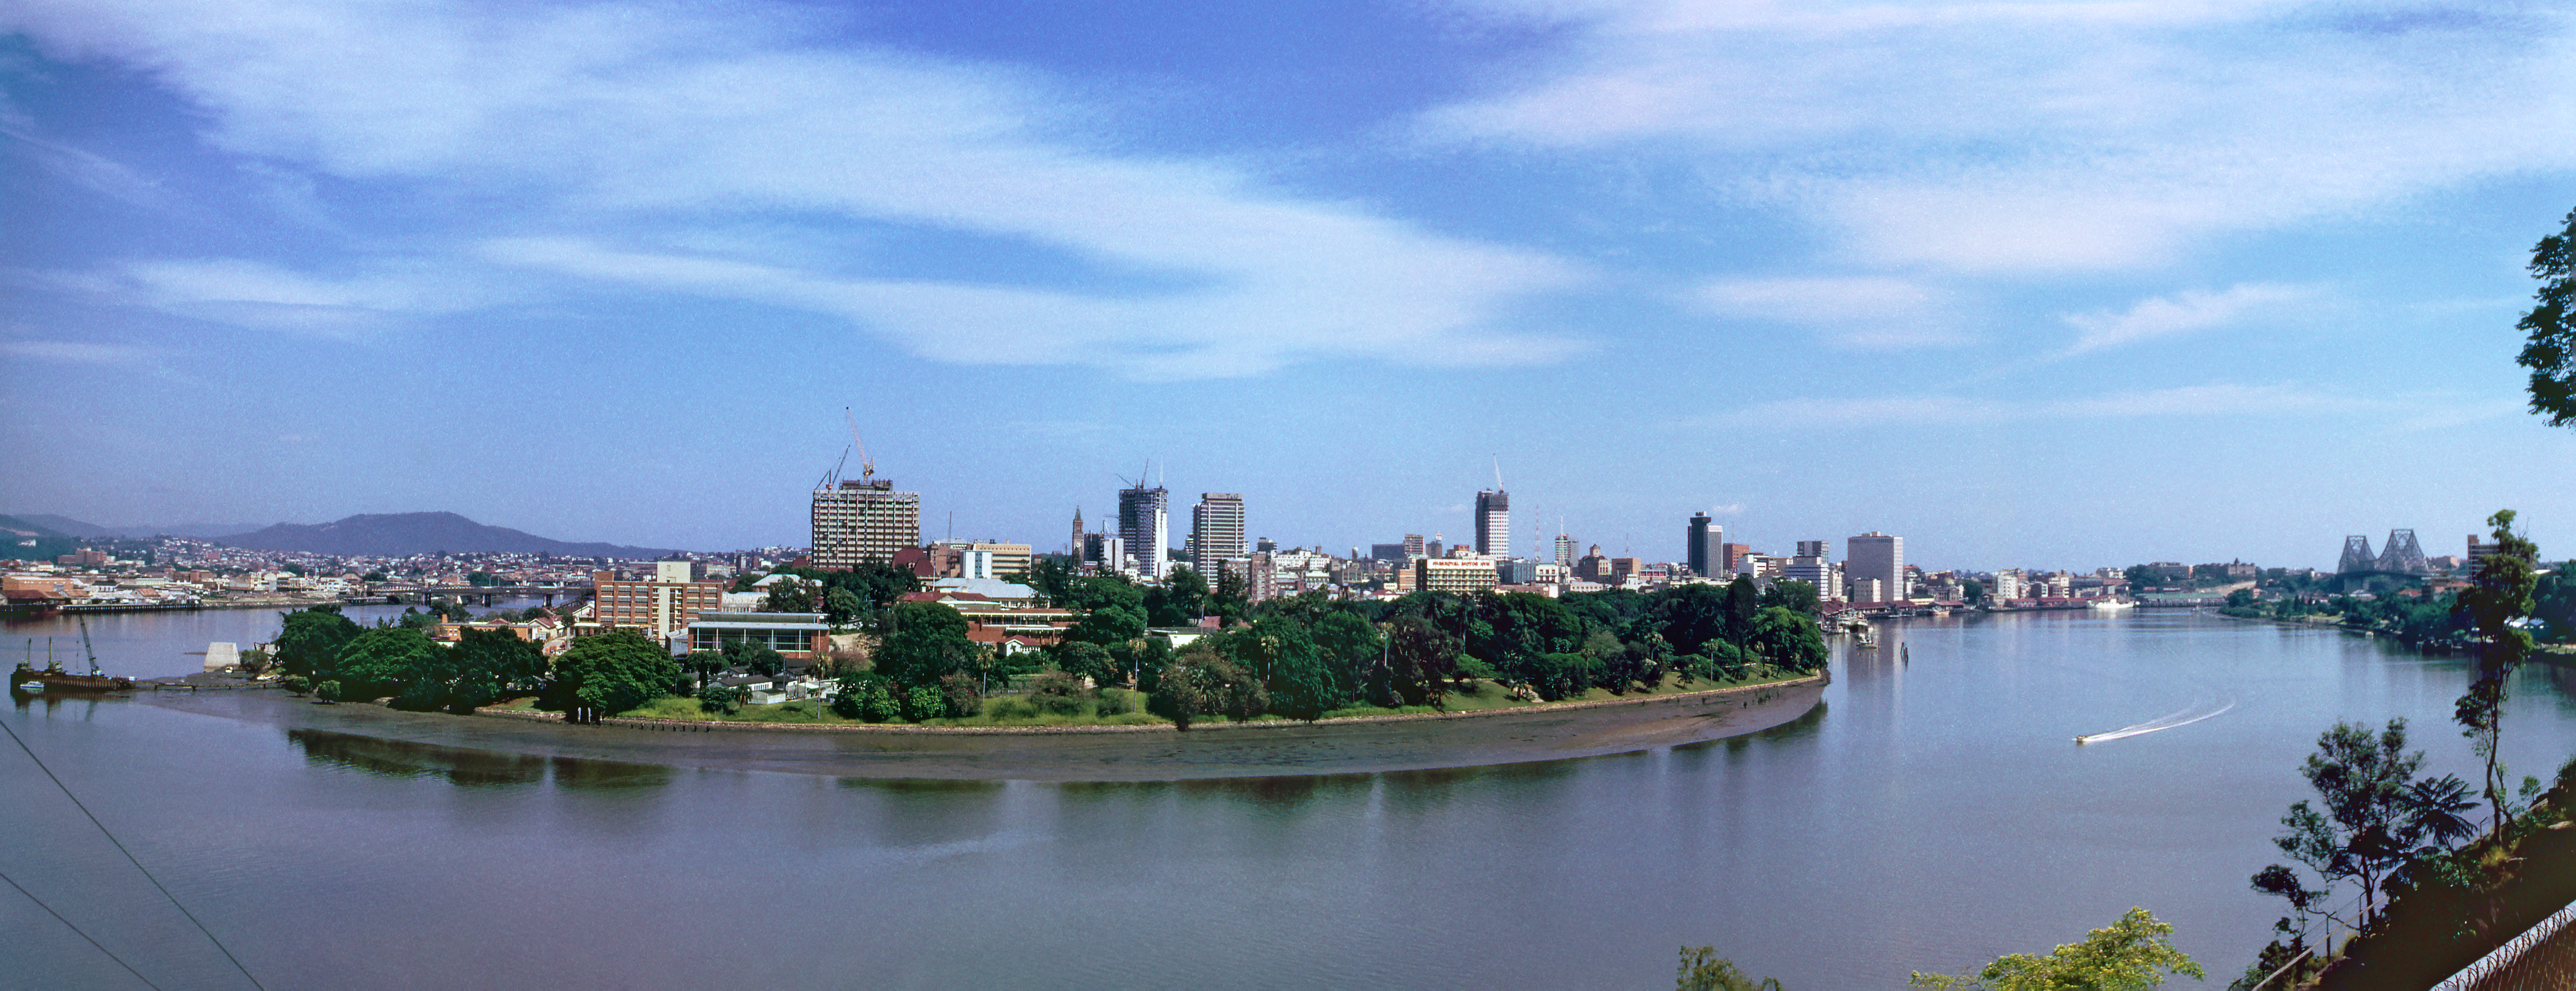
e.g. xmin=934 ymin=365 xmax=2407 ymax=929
xmin=0 ymin=0 xmax=2576 ymax=569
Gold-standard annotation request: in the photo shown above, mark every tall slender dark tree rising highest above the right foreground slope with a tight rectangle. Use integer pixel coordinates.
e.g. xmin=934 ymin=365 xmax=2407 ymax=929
xmin=2452 ymin=510 xmax=2540 ymax=834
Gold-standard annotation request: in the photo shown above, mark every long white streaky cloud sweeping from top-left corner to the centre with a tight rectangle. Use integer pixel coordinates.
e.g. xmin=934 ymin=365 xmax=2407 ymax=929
xmin=16 ymin=0 xmax=1589 ymax=376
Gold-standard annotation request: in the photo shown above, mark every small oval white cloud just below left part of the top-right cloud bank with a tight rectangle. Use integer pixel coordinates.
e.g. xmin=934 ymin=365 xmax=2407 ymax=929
xmin=1698 ymin=275 xmax=1973 ymax=350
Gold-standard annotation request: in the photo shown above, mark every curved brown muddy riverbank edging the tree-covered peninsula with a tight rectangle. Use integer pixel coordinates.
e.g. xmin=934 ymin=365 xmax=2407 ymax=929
xmin=139 ymin=674 xmax=1829 ymax=782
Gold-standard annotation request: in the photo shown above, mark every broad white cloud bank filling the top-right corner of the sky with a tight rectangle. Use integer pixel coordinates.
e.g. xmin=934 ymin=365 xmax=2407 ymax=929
xmin=1422 ymin=0 xmax=2576 ymax=273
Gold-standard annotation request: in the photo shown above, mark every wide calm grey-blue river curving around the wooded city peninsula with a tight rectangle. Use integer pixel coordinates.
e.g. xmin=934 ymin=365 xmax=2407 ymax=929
xmin=0 ymin=610 xmax=2576 ymax=991
